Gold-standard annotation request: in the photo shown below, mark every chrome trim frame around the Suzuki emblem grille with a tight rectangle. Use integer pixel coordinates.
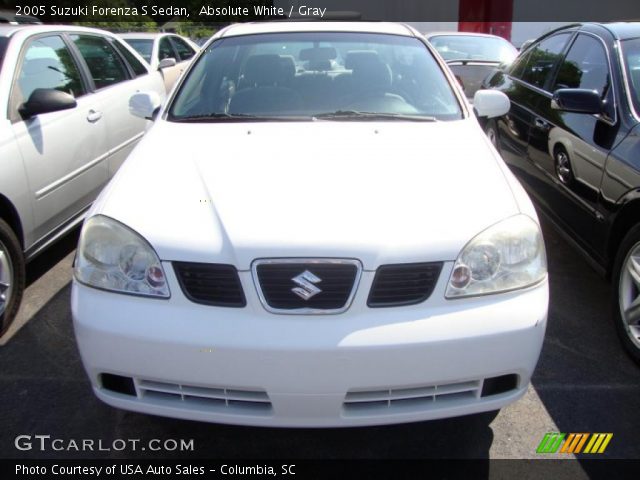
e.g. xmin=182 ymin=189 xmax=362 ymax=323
xmin=251 ymin=258 xmax=362 ymax=315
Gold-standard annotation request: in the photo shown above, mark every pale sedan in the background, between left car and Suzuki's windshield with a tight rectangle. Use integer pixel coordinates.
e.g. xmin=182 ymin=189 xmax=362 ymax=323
xmin=119 ymin=33 xmax=200 ymax=92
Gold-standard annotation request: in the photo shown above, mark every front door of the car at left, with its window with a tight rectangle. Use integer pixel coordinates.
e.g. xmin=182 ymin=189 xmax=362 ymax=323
xmin=9 ymin=34 xmax=109 ymax=244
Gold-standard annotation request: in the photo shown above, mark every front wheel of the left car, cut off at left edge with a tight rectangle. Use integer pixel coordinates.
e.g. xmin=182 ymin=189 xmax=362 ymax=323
xmin=0 ymin=219 xmax=25 ymax=335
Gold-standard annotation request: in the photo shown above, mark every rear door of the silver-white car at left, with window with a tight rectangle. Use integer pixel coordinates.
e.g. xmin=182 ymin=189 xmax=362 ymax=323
xmin=69 ymin=33 xmax=160 ymax=177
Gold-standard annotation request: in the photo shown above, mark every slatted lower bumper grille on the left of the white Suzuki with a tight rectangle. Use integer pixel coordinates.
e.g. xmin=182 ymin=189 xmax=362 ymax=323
xmin=137 ymin=379 xmax=272 ymax=415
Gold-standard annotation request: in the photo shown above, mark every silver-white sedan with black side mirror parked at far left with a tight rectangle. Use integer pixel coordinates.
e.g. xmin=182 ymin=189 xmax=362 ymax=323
xmin=0 ymin=25 xmax=165 ymax=334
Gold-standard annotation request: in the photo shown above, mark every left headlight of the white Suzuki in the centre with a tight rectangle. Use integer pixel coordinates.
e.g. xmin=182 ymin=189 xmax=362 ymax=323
xmin=74 ymin=215 xmax=170 ymax=298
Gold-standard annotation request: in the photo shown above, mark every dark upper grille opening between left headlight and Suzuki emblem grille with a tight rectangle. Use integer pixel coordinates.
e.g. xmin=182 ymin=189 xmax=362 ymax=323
xmin=173 ymin=262 xmax=247 ymax=307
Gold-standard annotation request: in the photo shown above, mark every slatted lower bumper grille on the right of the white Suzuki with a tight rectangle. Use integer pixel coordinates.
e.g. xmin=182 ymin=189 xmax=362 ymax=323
xmin=343 ymin=380 xmax=482 ymax=416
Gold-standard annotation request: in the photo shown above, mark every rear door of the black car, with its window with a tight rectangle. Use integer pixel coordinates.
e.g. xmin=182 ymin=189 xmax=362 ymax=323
xmin=498 ymin=32 xmax=573 ymax=187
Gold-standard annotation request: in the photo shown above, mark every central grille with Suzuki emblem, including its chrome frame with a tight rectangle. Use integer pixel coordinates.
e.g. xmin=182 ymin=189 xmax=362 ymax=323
xmin=253 ymin=259 xmax=361 ymax=313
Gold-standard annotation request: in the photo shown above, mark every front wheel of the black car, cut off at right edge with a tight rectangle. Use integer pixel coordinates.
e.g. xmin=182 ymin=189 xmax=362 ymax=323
xmin=612 ymin=225 xmax=640 ymax=364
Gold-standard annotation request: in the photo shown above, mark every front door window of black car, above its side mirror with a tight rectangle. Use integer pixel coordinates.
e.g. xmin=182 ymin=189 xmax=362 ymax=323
xmin=553 ymin=34 xmax=610 ymax=96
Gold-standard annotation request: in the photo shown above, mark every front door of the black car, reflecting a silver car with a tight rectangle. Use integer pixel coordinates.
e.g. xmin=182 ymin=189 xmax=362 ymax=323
xmin=529 ymin=32 xmax=619 ymax=254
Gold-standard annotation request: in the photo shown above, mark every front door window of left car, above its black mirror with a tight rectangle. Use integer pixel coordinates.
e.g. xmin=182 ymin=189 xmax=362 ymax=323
xmin=11 ymin=35 xmax=85 ymax=113
